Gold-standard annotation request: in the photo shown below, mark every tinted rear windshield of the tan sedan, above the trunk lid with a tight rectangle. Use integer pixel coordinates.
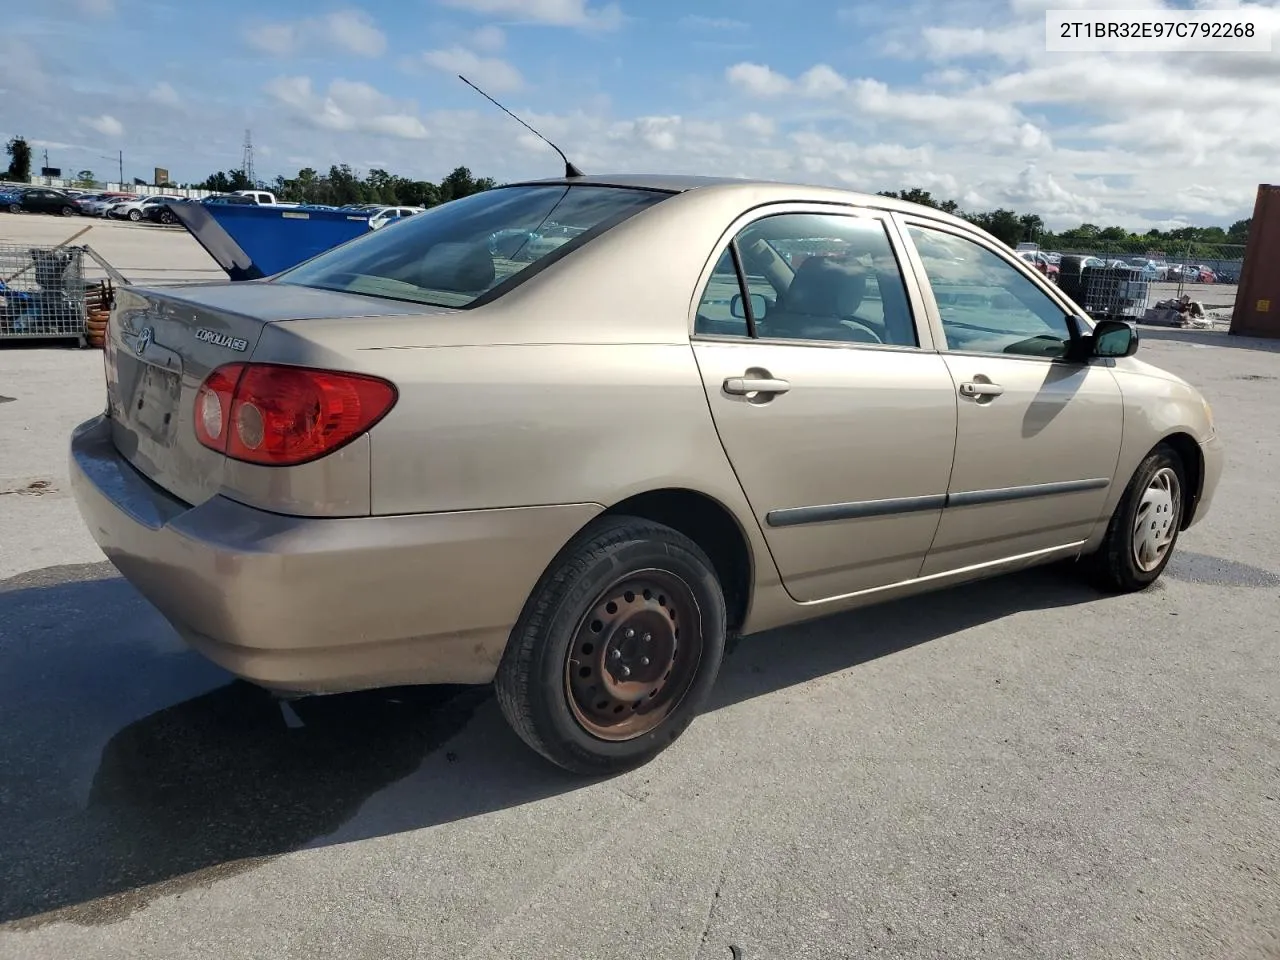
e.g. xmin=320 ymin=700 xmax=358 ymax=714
xmin=275 ymin=186 xmax=668 ymax=307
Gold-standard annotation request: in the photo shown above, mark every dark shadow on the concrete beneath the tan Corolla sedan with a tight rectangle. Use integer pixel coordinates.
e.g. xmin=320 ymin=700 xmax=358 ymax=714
xmin=0 ymin=563 xmax=1097 ymax=928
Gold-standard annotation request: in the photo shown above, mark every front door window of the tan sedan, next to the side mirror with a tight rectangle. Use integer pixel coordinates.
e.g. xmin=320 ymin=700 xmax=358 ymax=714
xmin=908 ymin=227 xmax=1071 ymax=357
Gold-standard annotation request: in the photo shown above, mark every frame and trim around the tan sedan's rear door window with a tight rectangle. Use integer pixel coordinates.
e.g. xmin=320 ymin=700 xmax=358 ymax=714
xmin=689 ymin=200 xmax=938 ymax=353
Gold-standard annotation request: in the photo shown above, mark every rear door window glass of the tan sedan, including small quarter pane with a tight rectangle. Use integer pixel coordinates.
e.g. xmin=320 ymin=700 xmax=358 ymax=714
xmin=694 ymin=214 xmax=919 ymax=347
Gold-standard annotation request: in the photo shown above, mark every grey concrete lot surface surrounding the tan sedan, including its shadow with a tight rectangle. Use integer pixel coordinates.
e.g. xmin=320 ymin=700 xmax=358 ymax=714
xmin=0 ymin=218 xmax=1280 ymax=960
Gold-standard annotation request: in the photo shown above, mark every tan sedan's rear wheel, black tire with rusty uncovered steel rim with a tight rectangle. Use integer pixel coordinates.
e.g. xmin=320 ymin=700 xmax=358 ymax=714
xmin=494 ymin=517 xmax=727 ymax=776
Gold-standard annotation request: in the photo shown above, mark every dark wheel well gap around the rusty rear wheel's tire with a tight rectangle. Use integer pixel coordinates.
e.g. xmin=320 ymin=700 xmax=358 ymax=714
xmin=604 ymin=489 xmax=751 ymax=630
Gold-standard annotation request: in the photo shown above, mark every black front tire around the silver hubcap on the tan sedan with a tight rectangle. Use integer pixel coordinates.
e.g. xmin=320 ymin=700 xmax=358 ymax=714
xmin=1082 ymin=444 xmax=1187 ymax=593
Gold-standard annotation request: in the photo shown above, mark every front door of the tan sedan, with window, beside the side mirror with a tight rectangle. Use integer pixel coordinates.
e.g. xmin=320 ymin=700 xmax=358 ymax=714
xmin=906 ymin=223 xmax=1124 ymax=576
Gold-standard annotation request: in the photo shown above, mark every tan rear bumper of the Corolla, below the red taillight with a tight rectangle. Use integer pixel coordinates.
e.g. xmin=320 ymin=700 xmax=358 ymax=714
xmin=70 ymin=417 xmax=603 ymax=692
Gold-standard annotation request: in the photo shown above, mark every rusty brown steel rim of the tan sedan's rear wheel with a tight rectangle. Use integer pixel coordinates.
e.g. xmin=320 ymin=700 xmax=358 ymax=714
xmin=564 ymin=570 xmax=703 ymax=741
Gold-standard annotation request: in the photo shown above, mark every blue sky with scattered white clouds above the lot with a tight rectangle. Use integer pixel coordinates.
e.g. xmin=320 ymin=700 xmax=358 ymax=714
xmin=0 ymin=0 xmax=1280 ymax=228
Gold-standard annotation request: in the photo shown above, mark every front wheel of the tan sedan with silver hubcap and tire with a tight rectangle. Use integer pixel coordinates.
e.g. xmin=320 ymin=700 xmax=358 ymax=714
xmin=1084 ymin=444 xmax=1187 ymax=593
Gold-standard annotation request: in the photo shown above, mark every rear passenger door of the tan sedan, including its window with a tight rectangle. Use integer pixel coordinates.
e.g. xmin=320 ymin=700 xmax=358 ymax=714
xmin=692 ymin=207 xmax=957 ymax=602
